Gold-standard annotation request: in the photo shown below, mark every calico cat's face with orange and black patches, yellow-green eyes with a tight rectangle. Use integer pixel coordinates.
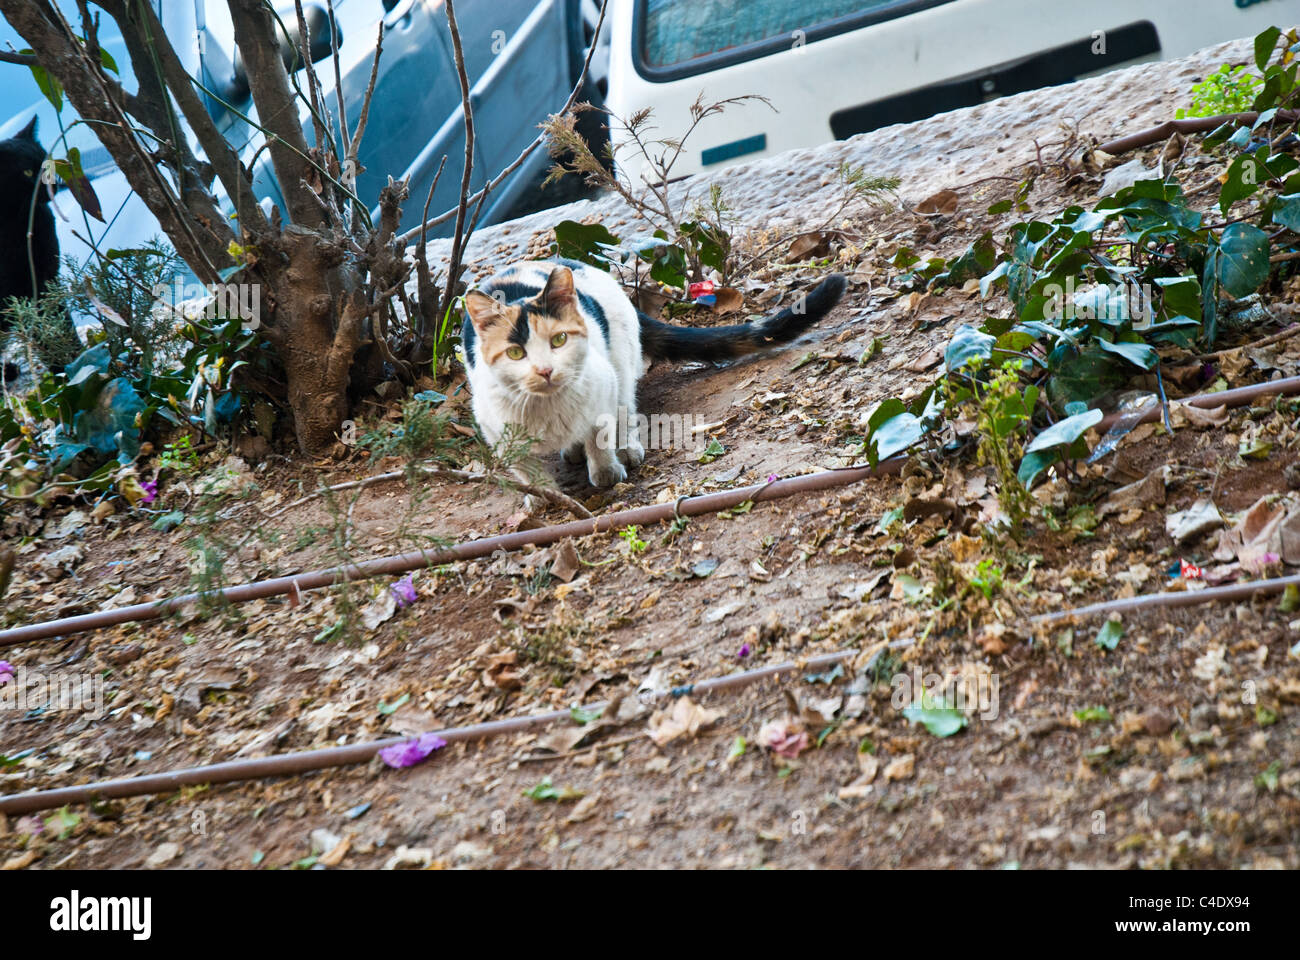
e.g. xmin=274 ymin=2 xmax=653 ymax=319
xmin=465 ymin=267 xmax=588 ymax=397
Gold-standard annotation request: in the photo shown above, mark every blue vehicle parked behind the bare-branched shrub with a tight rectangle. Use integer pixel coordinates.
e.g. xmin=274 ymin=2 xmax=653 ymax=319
xmin=0 ymin=0 xmax=603 ymax=260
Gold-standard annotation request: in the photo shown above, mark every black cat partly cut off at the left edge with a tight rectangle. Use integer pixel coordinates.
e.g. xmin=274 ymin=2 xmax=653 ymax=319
xmin=0 ymin=117 xmax=59 ymax=380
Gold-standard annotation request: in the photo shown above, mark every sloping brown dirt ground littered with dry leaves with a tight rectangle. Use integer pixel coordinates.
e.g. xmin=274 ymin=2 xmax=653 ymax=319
xmin=0 ymin=95 xmax=1300 ymax=869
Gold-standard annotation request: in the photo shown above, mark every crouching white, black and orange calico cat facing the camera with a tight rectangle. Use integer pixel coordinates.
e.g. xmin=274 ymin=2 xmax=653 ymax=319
xmin=462 ymin=260 xmax=845 ymax=487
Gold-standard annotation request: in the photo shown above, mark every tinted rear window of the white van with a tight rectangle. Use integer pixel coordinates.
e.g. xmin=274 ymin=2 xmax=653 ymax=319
xmin=641 ymin=0 xmax=915 ymax=68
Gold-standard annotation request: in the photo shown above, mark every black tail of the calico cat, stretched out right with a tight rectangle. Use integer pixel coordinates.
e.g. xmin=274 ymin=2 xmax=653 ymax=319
xmin=637 ymin=273 xmax=845 ymax=362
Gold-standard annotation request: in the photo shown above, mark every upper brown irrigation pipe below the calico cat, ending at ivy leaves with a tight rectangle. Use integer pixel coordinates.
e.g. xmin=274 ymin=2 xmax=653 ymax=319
xmin=0 ymin=457 xmax=904 ymax=647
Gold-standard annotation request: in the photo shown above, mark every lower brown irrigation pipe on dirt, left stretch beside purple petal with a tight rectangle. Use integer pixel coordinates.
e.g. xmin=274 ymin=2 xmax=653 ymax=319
xmin=0 ymin=650 xmax=861 ymax=816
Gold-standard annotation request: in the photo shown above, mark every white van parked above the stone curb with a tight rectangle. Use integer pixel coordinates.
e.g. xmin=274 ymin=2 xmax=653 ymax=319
xmin=606 ymin=0 xmax=1300 ymax=183
